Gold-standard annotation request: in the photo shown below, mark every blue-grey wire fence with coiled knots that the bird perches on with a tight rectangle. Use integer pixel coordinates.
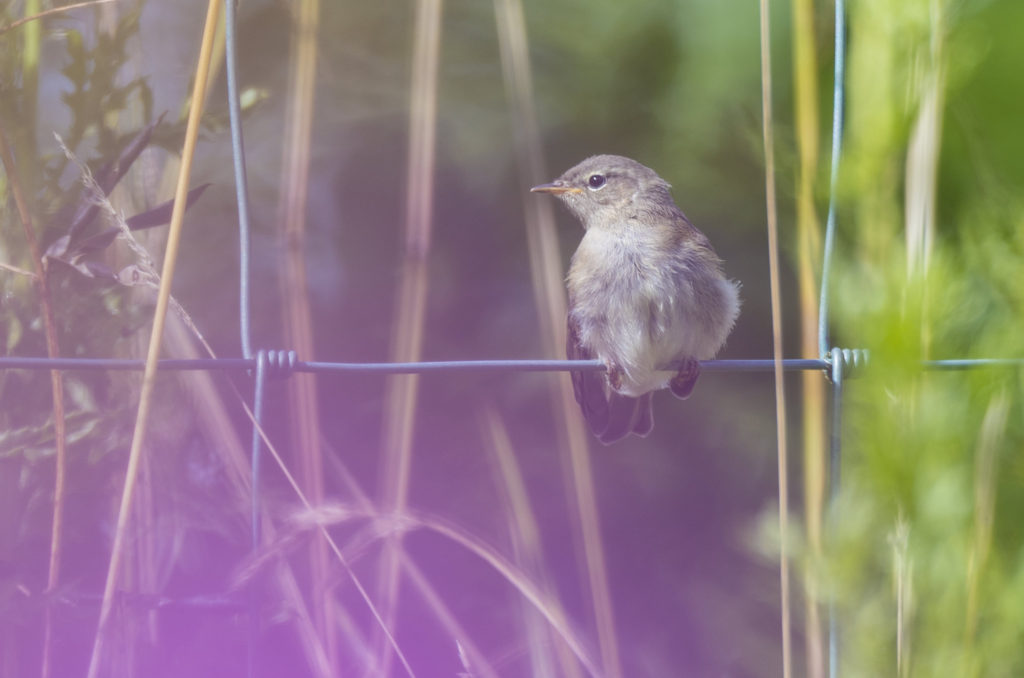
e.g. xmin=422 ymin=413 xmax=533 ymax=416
xmin=0 ymin=0 xmax=1024 ymax=678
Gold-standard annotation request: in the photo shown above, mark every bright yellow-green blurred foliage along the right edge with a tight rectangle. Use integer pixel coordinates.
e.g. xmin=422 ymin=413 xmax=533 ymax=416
xmin=821 ymin=0 xmax=1024 ymax=676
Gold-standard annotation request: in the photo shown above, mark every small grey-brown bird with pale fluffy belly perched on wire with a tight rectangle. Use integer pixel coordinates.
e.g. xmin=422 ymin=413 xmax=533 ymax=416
xmin=530 ymin=155 xmax=739 ymax=444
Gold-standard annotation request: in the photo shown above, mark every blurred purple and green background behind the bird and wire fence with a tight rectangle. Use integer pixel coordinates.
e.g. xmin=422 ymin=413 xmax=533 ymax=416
xmin=0 ymin=0 xmax=1024 ymax=677
